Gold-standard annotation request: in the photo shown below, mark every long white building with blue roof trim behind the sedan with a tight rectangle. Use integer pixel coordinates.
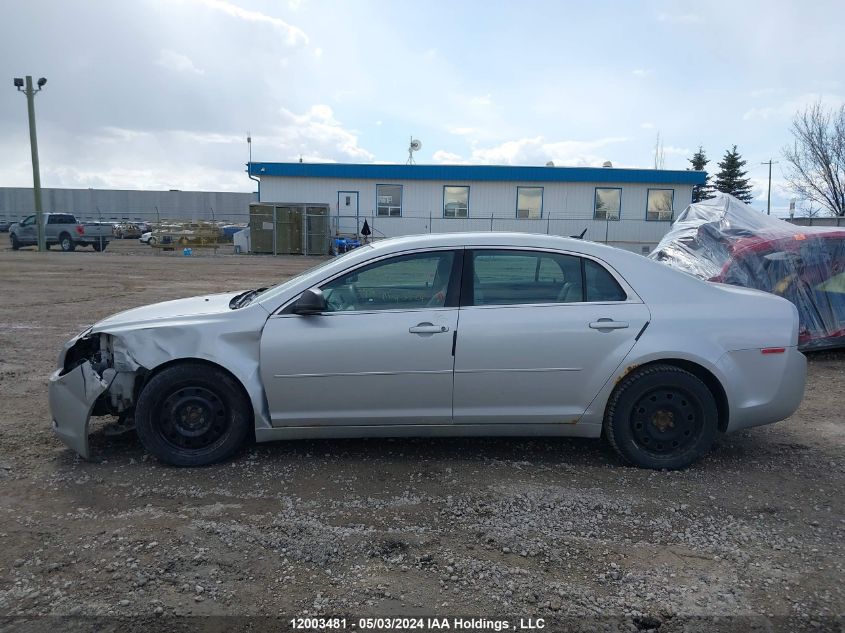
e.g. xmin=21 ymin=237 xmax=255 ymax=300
xmin=247 ymin=162 xmax=706 ymax=253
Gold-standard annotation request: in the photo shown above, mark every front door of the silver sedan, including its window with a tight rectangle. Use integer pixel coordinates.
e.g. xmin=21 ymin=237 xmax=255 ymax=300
xmin=261 ymin=250 xmax=461 ymax=426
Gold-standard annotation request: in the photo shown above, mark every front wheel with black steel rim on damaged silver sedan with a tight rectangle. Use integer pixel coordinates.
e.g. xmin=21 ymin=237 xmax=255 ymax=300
xmin=135 ymin=363 xmax=253 ymax=466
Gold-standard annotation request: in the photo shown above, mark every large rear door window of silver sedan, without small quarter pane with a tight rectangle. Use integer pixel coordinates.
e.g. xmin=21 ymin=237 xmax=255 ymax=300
xmin=472 ymin=251 xmax=583 ymax=305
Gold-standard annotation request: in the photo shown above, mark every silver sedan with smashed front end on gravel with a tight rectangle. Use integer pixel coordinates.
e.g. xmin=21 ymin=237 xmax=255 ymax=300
xmin=49 ymin=233 xmax=806 ymax=468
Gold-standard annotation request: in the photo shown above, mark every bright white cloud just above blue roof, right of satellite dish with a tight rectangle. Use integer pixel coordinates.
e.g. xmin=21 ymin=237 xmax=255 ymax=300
xmin=432 ymin=136 xmax=628 ymax=167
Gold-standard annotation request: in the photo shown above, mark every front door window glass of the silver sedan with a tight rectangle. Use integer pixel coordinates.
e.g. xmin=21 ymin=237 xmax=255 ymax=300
xmin=320 ymin=251 xmax=455 ymax=312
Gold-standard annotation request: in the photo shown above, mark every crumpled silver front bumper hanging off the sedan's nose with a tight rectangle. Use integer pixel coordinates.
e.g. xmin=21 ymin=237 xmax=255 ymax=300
xmin=50 ymin=362 xmax=115 ymax=459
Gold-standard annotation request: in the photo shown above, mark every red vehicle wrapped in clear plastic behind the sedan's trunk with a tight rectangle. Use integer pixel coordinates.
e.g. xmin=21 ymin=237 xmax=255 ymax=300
xmin=649 ymin=194 xmax=845 ymax=350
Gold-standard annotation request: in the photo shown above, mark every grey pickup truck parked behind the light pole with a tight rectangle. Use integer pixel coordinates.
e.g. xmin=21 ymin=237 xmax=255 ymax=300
xmin=9 ymin=213 xmax=114 ymax=251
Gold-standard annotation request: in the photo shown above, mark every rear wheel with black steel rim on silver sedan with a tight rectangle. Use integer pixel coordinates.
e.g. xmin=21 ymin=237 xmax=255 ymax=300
xmin=604 ymin=365 xmax=719 ymax=470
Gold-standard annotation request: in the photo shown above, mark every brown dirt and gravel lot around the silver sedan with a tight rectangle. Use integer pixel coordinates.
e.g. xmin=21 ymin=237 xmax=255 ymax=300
xmin=0 ymin=236 xmax=845 ymax=632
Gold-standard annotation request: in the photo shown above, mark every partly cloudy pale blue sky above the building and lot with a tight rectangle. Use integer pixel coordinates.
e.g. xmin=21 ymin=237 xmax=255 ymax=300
xmin=0 ymin=0 xmax=845 ymax=215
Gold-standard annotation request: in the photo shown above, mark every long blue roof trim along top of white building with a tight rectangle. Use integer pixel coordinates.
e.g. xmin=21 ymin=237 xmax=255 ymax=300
xmin=249 ymin=163 xmax=707 ymax=185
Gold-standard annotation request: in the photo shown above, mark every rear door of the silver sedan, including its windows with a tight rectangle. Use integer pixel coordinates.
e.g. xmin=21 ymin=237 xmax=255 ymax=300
xmin=454 ymin=249 xmax=650 ymax=424
